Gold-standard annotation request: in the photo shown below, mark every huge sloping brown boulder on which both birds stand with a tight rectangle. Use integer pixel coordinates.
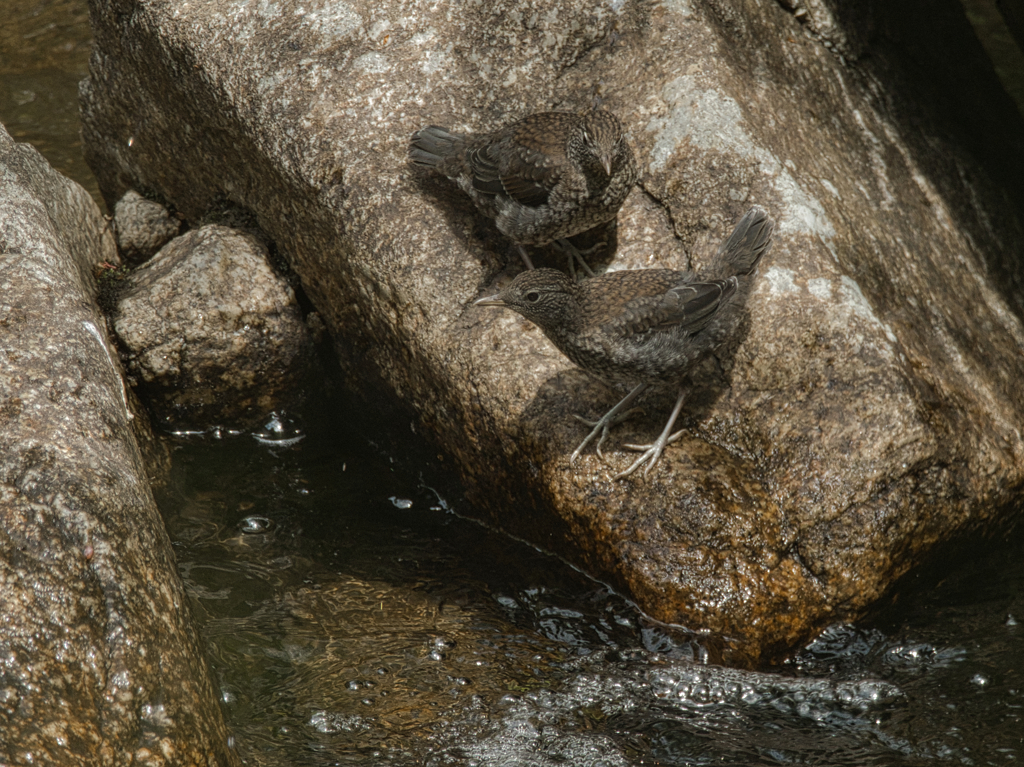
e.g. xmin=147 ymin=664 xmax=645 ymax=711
xmin=82 ymin=0 xmax=1024 ymax=663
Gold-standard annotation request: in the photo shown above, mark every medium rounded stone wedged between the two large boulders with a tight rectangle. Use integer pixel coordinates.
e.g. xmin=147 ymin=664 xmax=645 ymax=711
xmin=114 ymin=225 xmax=312 ymax=426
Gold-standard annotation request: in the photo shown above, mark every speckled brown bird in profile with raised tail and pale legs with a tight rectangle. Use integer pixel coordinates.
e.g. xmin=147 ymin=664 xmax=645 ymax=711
xmin=474 ymin=206 xmax=774 ymax=479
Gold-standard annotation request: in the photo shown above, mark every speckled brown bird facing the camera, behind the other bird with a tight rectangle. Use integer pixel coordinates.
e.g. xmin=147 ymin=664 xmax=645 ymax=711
xmin=409 ymin=110 xmax=639 ymax=276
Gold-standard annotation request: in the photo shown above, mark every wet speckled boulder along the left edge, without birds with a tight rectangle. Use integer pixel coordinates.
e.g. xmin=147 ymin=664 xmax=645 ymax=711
xmin=0 ymin=124 xmax=237 ymax=766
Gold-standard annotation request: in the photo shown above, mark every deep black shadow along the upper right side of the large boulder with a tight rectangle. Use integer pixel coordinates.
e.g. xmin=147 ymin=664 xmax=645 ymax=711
xmin=790 ymin=0 xmax=1024 ymax=319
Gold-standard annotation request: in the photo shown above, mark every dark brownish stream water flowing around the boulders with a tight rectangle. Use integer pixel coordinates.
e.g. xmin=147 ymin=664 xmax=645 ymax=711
xmin=8 ymin=0 xmax=1024 ymax=766
